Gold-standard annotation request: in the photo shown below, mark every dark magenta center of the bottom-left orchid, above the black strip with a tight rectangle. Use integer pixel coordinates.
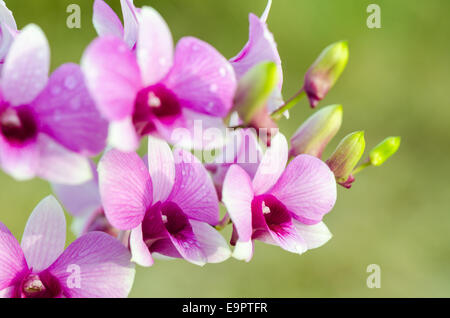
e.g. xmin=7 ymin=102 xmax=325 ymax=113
xmin=21 ymin=272 xmax=61 ymax=298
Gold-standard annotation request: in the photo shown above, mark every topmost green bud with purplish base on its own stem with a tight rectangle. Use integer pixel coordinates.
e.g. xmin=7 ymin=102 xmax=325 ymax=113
xmin=303 ymin=41 xmax=348 ymax=108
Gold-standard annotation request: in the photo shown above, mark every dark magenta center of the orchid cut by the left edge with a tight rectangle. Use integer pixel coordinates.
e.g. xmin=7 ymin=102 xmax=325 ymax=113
xmin=0 ymin=106 xmax=38 ymax=145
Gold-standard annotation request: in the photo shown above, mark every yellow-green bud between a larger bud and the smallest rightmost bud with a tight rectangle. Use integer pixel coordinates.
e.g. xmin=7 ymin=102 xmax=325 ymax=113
xmin=327 ymin=131 xmax=366 ymax=183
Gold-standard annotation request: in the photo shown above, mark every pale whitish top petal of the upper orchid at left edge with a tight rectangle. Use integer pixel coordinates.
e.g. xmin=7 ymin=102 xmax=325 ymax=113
xmin=1 ymin=24 xmax=50 ymax=106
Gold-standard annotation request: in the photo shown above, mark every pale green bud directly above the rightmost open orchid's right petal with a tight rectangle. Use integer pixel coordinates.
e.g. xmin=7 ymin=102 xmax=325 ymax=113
xmin=290 ymin=105 xmax=343 ymax=158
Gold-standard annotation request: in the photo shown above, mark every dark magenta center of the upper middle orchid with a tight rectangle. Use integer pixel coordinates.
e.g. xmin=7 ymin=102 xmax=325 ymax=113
xmin=133 ymin=84 xmax=181 ymax=136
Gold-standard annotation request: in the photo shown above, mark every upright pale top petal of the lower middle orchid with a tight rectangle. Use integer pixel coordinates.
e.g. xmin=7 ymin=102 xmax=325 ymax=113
xmin=147 ymin=137 xmax=175 ymax=202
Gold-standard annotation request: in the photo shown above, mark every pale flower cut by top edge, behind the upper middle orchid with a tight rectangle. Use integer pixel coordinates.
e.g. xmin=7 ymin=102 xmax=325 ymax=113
xmin=93 ymin=0 xmax=139 ymax=49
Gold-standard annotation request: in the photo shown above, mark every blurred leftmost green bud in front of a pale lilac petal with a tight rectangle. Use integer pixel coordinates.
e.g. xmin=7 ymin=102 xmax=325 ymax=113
xmin=234 ymin=62 xmax=278 ymax=124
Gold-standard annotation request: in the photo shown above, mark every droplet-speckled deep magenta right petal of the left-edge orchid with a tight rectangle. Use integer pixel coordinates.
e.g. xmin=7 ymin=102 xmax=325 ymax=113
xmin=33 ymin=63 xmax=108 ymax=156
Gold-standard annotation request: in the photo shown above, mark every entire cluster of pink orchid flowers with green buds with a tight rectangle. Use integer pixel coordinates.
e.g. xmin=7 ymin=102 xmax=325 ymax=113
xmin=0 ymin=0 xmax=400 ymax=298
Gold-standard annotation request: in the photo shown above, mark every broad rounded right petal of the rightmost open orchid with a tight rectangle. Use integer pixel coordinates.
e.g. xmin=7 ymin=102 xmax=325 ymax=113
xmin=270 ymin=155 xmax=336 ymax=225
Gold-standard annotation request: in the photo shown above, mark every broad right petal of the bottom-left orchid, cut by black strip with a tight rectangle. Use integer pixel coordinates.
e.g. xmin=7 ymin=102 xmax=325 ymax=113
xmin=48 ymin=232 xmax=135 ymax=298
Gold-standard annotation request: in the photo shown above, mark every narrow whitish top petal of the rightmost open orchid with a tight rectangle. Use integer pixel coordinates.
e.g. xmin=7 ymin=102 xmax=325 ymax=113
xmin=253 ymin=133 xmax=288 ymax=195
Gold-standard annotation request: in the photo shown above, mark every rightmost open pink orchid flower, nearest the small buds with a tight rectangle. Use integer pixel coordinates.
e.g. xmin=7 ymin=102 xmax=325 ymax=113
xmin=222 ymin=133 xmax=336 ymax=261
